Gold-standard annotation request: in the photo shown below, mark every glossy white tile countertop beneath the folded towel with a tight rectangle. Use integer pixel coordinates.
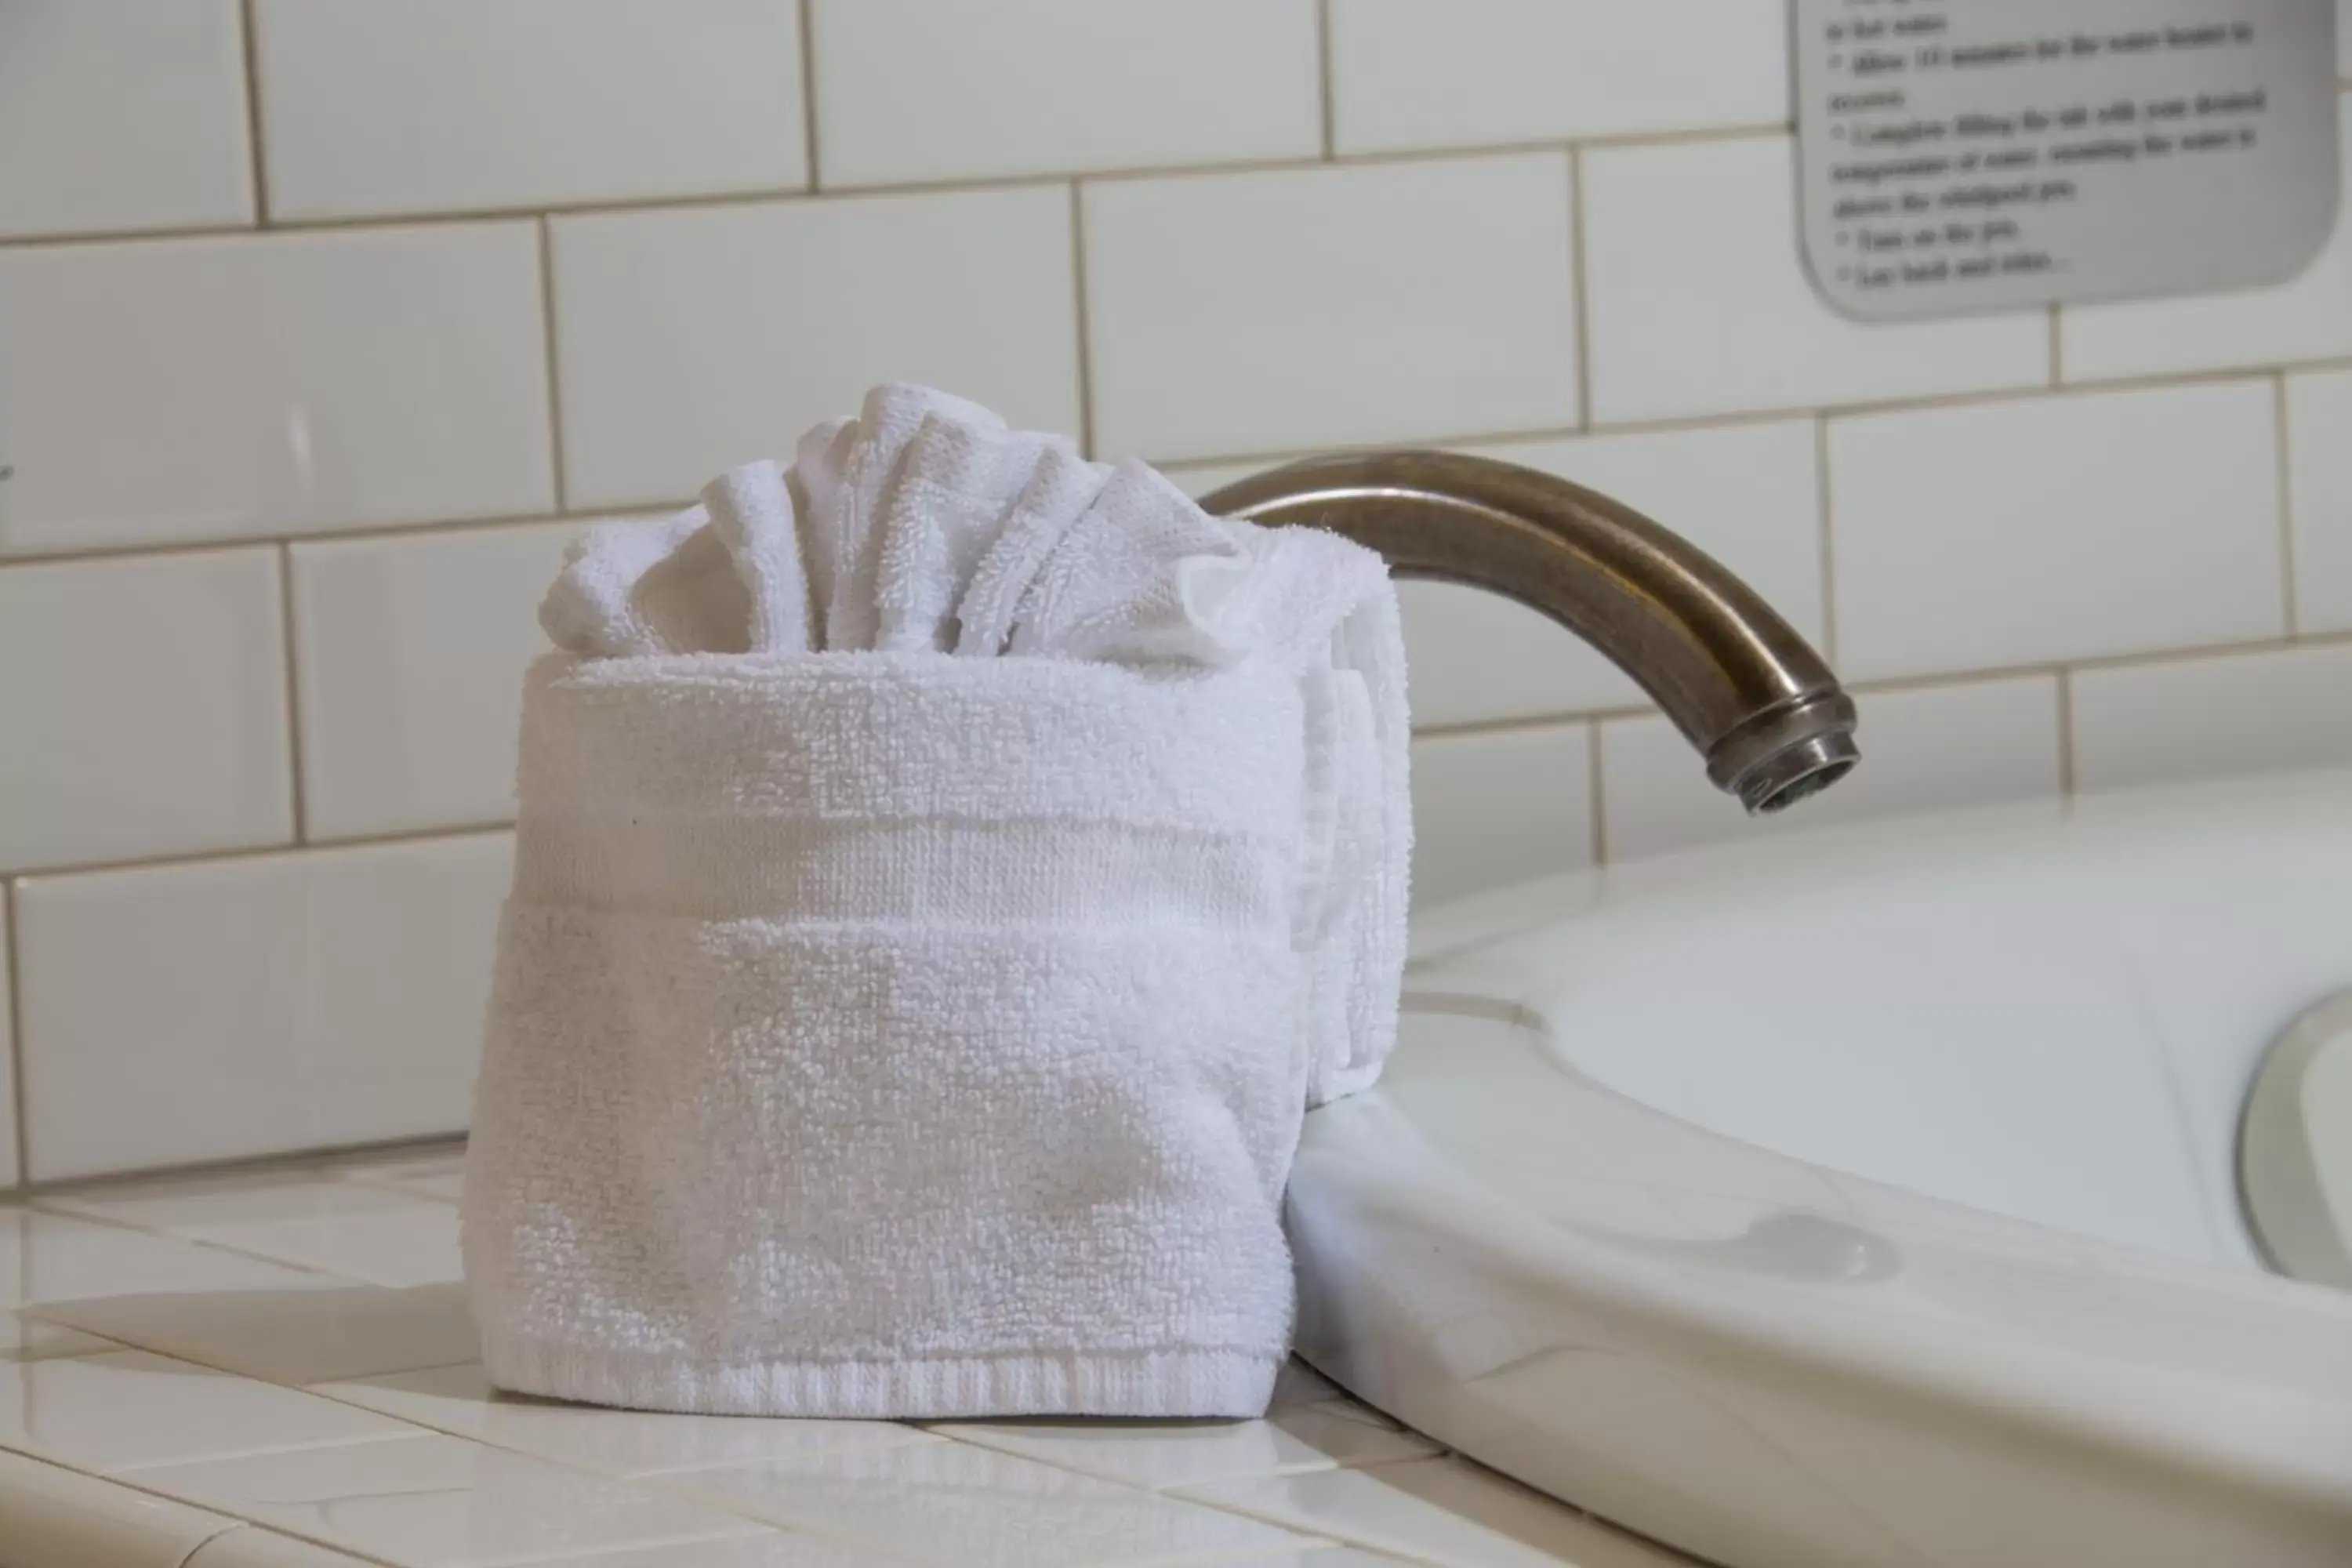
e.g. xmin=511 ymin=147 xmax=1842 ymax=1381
xmin=0 ymin=1147 xmax=1689 ymax=1568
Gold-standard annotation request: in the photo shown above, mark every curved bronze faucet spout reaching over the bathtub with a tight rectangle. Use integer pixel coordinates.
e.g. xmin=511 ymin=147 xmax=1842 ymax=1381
xmin=1202 ymin=452 xmax=1860 ymax=813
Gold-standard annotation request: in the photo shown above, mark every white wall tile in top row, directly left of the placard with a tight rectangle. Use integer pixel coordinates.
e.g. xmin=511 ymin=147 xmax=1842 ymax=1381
xmin=1331 ymin=0 xmax=1790 ymax=153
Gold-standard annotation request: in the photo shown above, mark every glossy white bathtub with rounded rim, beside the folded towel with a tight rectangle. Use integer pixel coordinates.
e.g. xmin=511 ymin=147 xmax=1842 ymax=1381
xmin=1291 ymin=774 xmax=2352 ymax=1568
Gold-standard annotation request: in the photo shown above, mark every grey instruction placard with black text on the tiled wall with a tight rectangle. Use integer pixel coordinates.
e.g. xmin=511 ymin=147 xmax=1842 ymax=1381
xmin=1792 ymin=0 xmax=2343 ymax=320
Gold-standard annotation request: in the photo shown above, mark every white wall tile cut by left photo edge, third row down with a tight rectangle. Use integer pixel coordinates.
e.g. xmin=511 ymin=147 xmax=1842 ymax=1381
xmin=0 ymin=550 xmax=294 ymax=869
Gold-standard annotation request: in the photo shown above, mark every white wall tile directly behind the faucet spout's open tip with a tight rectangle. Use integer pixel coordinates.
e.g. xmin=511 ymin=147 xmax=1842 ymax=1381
xmin=1599 ymin=675 xmax=2060 ymax=860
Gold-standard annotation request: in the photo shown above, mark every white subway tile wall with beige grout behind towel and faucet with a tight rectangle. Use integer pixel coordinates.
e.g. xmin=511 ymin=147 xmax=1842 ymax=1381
xmin=0 ymin=0 xmax=2352 ymax=1185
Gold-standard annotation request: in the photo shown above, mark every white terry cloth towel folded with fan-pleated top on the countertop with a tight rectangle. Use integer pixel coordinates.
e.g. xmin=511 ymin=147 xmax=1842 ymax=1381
xmin=463 ymin=388 xmax=1409 ymax=1417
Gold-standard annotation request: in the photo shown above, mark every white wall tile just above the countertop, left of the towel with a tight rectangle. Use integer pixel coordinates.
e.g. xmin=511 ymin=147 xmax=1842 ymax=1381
xmin=16 ymin=834 xmax=510 ymax=1180
